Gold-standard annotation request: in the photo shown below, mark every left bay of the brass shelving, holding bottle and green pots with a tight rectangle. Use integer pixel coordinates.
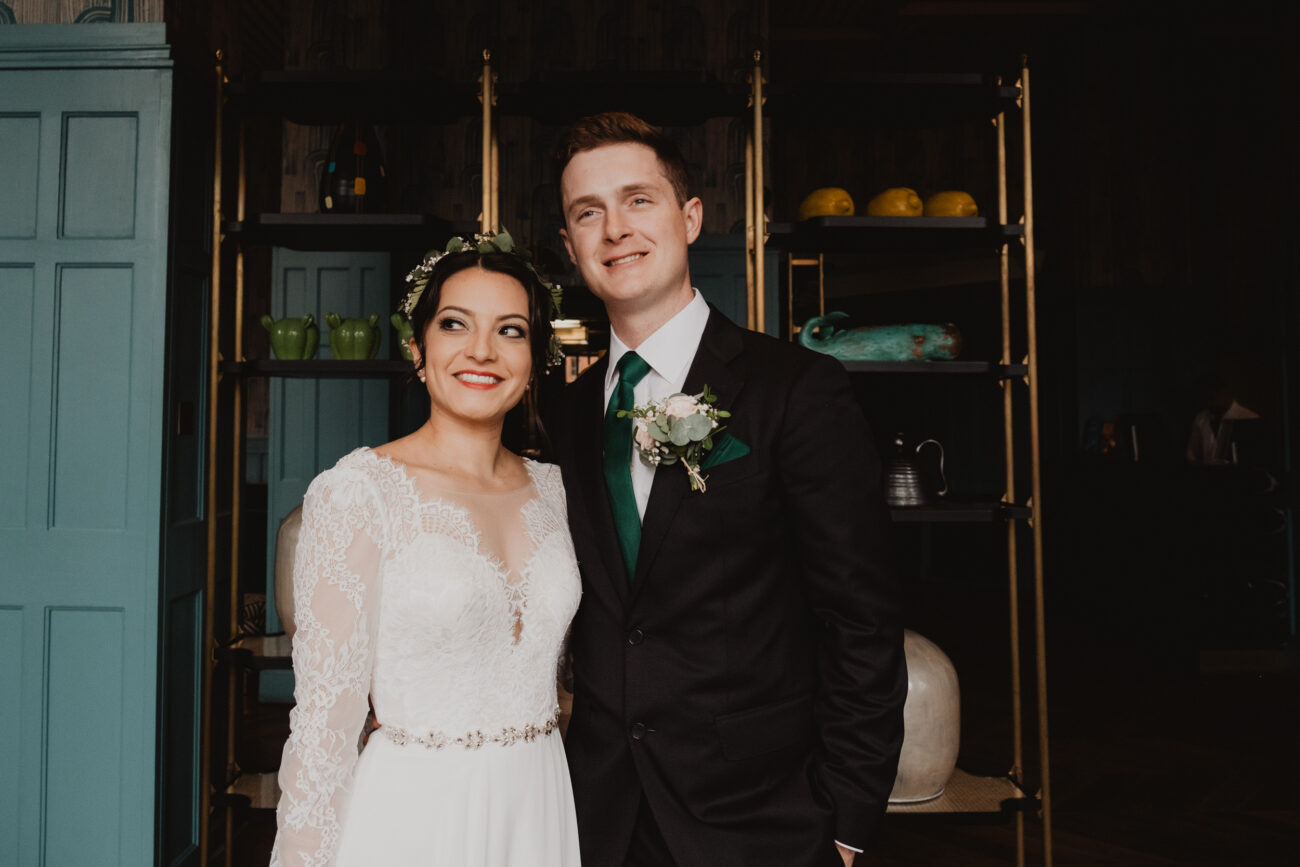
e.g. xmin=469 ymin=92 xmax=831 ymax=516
xmin=199 ymin=51 xmax=499 ymax=867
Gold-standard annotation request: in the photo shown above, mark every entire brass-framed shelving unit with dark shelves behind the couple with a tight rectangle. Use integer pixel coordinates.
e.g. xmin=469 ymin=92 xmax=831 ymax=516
xmin=200 ymin=42 xmax=1052 ymax=867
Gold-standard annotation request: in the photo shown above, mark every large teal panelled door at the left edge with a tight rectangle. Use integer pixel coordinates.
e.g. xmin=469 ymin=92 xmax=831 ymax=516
xmin=0 ymin=25 xmax=172 ymax=867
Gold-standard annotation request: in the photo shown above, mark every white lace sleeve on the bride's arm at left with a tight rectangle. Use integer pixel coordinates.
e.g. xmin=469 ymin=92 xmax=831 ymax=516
xmin=270 ymin=468 xmax=382 ymax=867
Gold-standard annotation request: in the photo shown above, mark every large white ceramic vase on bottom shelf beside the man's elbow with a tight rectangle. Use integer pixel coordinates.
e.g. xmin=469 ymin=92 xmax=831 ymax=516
xmin=889 ymin=626 xmax=962 ymax=803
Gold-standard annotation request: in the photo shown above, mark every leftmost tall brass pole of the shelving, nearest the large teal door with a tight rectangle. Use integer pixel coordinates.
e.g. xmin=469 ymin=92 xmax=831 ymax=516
xmin=199 ymin=51 xmax=225 ymax=867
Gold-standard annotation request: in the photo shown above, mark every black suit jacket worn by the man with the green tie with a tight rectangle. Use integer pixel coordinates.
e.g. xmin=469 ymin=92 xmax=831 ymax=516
xmin=553 ymin=309 xmax=907 ymax=867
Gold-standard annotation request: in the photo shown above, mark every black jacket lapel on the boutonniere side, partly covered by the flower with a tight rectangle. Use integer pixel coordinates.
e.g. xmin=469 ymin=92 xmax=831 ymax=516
xmin=631 ymin=307 xmax=745 ymax=602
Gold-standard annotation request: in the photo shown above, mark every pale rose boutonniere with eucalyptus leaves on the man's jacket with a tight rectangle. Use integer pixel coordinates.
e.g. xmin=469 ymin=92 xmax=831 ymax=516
xmin=619 ymin=385 xmax=731 ymax=491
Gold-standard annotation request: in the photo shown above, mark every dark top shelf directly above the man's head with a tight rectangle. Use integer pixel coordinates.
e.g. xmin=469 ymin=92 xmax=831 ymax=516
xmin=497 ymin=71 xmax=749 ymax=126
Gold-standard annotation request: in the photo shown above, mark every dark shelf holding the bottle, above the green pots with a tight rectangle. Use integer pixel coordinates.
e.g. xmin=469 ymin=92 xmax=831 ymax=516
xmin=221 ymin=213 xmax=478 ymax=251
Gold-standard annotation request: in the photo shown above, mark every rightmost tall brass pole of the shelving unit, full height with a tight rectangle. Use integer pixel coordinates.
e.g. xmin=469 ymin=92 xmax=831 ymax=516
xmin=1021 ymin=57 xmax=1052 ymax=867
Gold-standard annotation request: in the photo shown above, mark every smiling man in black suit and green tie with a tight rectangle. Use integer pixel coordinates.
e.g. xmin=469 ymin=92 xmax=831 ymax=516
xmin=554 ymin=113 xmax=907 ymax=867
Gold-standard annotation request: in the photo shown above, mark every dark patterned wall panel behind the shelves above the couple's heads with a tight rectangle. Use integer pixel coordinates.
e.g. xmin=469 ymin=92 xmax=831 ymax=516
xmin=271 ymin=0 xmax=767 ymax=240
